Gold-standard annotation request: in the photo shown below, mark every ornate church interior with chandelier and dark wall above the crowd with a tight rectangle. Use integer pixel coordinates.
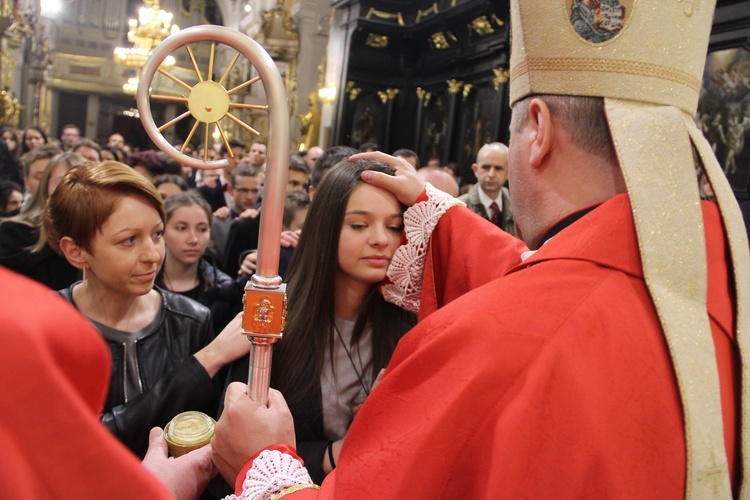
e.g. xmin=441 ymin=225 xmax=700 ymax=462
xmin=0 ymin=0 xmax=750 ymax=200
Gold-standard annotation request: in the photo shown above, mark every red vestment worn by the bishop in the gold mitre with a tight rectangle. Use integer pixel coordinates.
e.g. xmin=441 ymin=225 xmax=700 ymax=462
xmin=284 ymin=195 xmax=738 ymax=499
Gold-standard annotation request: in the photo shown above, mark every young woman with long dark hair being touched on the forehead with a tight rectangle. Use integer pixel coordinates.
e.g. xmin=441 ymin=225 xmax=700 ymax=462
xmin=226 ymin=161 xmax=416 ymax=482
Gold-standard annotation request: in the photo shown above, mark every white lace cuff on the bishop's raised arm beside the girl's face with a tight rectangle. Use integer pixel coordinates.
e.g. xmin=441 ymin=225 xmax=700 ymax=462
xmin=382 ymin=182 xmax=466 ymax=313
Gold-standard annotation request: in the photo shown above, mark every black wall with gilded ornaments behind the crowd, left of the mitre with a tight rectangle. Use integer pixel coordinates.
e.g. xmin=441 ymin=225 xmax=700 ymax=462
xmin=334 ymin=0 xmax=509 ymax=184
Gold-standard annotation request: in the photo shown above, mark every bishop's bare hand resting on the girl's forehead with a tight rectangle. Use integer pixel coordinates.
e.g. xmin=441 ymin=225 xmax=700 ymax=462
xmin=349 ymin=151 xmax=425 ymax=207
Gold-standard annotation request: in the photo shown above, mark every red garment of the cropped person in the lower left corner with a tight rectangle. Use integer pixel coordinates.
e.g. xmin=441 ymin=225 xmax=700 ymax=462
xmin=0 ymin=268 xmax=172 ymax=500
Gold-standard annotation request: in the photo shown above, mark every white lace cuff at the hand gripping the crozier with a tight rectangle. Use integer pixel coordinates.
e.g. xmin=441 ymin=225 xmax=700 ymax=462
xmin=225 ymin=450 xmax=316 ymax=500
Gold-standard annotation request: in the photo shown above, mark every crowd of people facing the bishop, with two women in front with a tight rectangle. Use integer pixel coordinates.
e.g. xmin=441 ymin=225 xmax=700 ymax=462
xmin=0 ymin=121 xmax=470 ymax=498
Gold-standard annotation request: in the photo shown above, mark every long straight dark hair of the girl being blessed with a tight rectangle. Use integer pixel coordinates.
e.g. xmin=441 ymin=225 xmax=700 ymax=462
xmin=271 ymin=160 xmax=416 ymax=413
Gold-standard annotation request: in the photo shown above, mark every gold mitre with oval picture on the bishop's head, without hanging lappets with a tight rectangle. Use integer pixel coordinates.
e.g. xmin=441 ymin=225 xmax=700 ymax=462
xmin=510 ymin=0 xmax=715 ymax=112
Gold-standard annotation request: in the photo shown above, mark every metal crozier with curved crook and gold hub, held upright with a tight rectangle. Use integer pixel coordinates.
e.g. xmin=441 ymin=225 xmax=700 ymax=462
xmin=136 ymin=25 xmax=290 ymax=404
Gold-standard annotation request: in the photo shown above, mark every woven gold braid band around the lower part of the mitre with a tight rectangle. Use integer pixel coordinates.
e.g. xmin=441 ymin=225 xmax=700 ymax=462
xmin=510 ymin=57 xmax=701 ymax=92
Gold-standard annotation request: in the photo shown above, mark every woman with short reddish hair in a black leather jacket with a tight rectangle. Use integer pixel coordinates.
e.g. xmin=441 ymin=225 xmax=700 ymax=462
xmin=44 ymin=161 xmax=250 ymax=456
